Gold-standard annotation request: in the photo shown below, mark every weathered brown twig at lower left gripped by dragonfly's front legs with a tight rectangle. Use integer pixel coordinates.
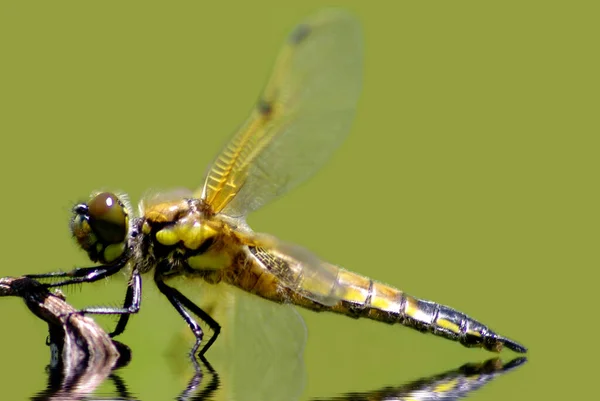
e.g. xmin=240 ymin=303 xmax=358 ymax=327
xmin=0 ymin=277 xmax=129 ymax=400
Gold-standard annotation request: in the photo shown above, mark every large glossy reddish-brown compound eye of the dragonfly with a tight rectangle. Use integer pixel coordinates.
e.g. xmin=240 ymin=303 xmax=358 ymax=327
xmin=87 ymin=192 xmax=128 ymax=244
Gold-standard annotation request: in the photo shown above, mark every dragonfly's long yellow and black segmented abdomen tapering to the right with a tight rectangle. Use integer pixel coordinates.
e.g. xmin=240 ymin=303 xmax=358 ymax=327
xmin=244 ymin=240 xmax=526 ymax=352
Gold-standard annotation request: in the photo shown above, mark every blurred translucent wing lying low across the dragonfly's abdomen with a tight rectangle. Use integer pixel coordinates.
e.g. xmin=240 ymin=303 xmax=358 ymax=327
xmin=248 ymin=234 xmax=346 ymax=306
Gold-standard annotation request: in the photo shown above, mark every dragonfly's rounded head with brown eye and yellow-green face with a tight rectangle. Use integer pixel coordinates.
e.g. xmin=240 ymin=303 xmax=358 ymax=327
xmin=71 ymin=192 xmax=129 ymax=263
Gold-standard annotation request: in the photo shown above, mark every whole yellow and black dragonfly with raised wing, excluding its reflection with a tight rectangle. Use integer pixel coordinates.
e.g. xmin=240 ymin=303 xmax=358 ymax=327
xmin=30 ymin=7 xmax=526 ymax=354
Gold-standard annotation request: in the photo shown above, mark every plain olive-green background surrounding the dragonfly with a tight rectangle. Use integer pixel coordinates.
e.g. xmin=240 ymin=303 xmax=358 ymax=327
xmin=0 ymin=0 xmax=600 ymax=400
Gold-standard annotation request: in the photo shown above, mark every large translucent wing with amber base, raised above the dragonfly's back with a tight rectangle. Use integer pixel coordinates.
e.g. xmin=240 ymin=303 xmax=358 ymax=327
xmin=196 ymin=10 xmax=363 ymax=217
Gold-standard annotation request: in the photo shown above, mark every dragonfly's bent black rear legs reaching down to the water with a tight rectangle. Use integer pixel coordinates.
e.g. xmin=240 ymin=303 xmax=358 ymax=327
xmin=154 ymin=266 xmax=221 ymax=357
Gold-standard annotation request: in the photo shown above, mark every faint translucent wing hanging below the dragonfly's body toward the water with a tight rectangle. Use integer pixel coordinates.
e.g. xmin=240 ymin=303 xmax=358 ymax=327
xmin=164 ymin=278 xmax=307 ymax=401
